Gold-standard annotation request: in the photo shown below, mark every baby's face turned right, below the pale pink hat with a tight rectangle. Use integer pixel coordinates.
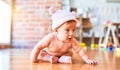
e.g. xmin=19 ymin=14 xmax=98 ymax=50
xmin=57 ymin=21 xmax=76 ymax=42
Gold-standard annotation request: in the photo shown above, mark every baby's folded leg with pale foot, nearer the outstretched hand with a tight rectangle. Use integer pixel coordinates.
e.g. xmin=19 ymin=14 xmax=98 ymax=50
xmin=58 ymin=52 xmax=73 ymax=63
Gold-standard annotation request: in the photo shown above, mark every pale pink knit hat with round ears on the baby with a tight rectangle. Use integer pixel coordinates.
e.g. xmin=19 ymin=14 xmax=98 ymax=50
xmin=49 ymin=7 xmax=77 ymax=30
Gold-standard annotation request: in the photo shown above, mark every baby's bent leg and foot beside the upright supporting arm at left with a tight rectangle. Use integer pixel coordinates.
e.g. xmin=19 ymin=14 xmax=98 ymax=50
xmin=38 ymin=50 xmax=58 ymax=63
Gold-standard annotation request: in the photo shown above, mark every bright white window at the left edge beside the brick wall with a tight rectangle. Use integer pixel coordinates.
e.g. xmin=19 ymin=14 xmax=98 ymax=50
xmin=0 ymin=0 xmax=11 ymax=44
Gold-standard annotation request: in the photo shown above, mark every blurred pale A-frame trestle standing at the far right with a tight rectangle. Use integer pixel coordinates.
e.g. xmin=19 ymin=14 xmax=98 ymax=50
xmin=99 ymin=21 xmax=119 ymax=48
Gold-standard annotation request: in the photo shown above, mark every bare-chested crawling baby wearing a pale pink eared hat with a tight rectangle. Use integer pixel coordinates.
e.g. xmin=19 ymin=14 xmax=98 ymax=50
xmin=31 ymin=7 xmax=97 ymax=64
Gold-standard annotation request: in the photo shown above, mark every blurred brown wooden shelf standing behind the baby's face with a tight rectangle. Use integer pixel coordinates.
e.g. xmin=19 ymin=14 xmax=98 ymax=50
xmin=79 ymin=17 xmax=95 ymax=43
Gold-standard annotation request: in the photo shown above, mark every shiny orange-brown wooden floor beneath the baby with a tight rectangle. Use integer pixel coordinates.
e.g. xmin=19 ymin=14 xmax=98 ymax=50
xmin=0 ymin=49 xmax=120 ymax=70
